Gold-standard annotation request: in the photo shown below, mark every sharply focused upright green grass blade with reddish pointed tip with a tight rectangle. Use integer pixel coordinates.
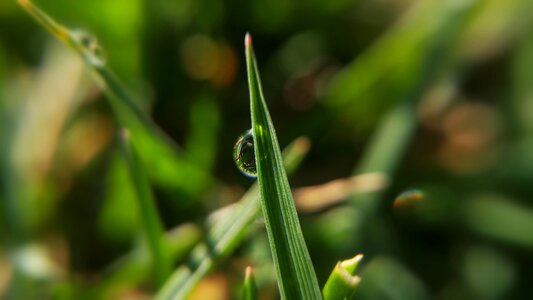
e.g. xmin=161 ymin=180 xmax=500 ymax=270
xmin=245 ymin=34 xmax=321 ymax=299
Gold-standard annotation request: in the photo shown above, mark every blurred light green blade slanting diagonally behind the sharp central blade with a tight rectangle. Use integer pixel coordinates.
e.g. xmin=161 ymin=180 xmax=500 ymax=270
xmin=156 ymin=138 xmax=309 ymax=300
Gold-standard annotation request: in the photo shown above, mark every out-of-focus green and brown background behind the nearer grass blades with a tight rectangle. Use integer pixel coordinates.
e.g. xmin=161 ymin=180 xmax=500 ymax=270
xmin=0 ymin=0 xmax=533 ymax=299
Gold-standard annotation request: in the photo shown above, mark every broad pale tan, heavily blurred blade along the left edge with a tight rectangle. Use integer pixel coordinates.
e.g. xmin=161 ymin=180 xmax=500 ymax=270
xmin=0 ymin=44 xmax=83 ymax=246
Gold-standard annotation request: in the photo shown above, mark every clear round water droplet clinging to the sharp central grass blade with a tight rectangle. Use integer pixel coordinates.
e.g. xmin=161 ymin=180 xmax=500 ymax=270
xmin=233 ymin=129 xmax=257 ymax=178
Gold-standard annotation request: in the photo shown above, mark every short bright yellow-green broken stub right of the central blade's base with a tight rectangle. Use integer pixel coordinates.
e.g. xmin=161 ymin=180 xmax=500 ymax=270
xmin=322 ymin=254 xmax=363 ymax=300
